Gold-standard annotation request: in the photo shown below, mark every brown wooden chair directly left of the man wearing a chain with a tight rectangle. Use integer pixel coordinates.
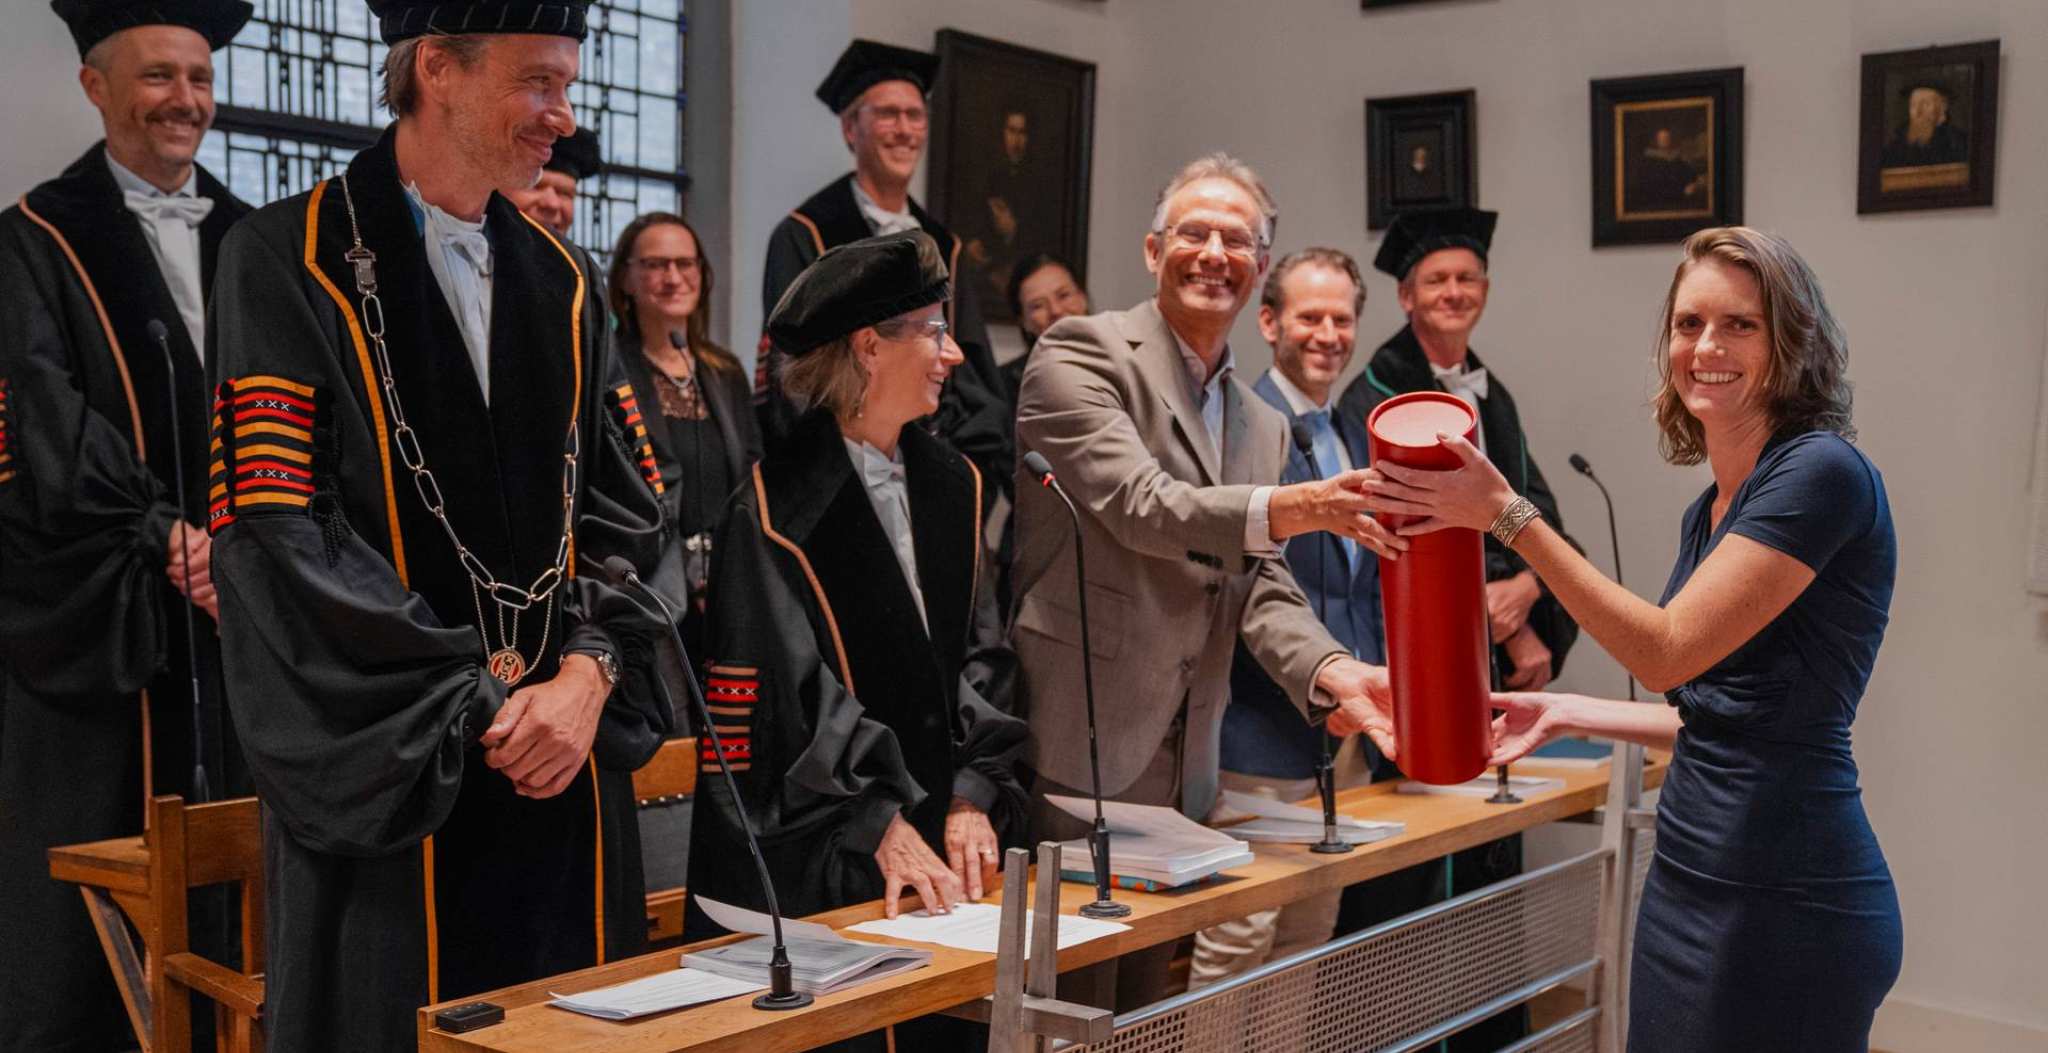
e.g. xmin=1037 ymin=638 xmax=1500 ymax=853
xmin=147 ymin=797 xmax=264 ymax=1053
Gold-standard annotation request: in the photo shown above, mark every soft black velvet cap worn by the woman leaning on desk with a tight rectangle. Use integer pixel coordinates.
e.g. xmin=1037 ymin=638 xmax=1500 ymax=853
xmin=768 ymin=229 xmax=952 ymax=356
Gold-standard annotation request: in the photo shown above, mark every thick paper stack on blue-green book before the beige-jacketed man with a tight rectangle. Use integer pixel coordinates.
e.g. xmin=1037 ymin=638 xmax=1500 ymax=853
xmin=1047 ymin=795 xmax=1251 ymax=889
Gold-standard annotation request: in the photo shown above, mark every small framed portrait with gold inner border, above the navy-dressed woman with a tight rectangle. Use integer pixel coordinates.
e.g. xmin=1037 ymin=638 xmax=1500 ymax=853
xmin=1593 ymin=68 xmax=1743 ymax=246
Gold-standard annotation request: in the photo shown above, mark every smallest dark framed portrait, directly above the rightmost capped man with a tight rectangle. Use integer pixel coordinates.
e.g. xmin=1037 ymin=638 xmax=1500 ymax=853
xmin=1366 ymin=90 xmax=1479 ymax=229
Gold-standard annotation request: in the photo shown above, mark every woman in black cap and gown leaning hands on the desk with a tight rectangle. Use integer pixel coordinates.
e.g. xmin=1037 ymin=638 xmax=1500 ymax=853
xmin=684 ymin=231 xmax=1026 ymax=936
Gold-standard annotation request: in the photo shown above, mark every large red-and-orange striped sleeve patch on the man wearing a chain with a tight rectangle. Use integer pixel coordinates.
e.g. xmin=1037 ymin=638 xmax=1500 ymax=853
xmin=207 ymin=375 xmax=319 ymax=533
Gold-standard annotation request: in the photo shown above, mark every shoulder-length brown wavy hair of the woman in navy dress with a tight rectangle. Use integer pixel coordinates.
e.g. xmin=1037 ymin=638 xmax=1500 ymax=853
xmin=1651 ymin=227 xmax=1855 ymax=465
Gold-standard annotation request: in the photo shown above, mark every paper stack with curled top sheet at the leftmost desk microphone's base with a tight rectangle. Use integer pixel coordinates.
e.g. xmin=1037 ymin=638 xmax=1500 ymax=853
xmin=682 ymin=897 xmax=932 ymax=994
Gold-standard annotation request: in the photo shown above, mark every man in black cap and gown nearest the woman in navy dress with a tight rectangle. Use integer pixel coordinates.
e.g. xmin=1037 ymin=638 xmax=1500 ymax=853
xmin=1337 ymin=209 xmax=1579 ymax=1051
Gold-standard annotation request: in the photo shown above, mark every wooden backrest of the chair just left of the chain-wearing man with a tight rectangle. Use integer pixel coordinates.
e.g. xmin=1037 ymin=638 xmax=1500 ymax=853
xmin=147 ymin=795 xmax=264 ymax=1051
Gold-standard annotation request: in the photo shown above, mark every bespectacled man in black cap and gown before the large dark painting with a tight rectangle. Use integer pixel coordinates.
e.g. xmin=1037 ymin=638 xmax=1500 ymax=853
xmin=754 ymin=41 xmax=1014 ymax=490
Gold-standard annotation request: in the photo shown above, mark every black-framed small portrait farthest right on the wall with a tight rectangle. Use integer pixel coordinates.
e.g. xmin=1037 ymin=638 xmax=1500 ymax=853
xmin=1855 ymin=41 xmax=1999 ymax=213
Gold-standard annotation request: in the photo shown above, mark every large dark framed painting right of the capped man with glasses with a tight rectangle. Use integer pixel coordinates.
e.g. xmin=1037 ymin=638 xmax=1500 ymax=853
xmin=926 ymin=29 xmax=1096 ymax=322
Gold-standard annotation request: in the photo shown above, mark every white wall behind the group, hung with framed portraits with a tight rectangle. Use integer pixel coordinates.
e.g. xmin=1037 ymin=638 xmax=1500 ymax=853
xmin=735 ymin=0 xmax=2048 ymax=1051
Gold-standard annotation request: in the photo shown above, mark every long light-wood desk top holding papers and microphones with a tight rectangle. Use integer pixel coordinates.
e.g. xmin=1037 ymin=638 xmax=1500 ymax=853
xmin=420 ymin=758 xmax=1663 ymax=1053
